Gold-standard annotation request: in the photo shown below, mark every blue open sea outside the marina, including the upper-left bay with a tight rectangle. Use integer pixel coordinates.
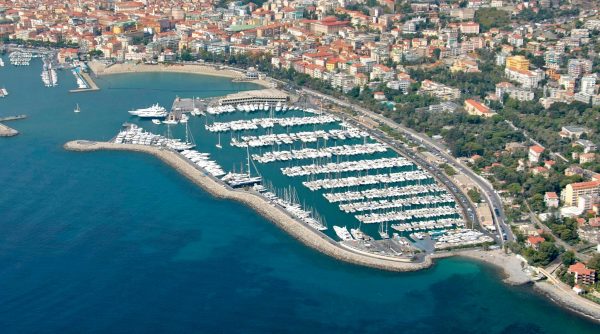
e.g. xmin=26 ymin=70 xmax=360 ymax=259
xmin=0 ymin=57 xmax=599 ymax=333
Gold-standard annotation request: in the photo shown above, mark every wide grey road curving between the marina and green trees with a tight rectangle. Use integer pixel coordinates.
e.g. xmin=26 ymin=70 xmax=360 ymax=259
xmin=301 ymin=88 xmax=514 ymax=244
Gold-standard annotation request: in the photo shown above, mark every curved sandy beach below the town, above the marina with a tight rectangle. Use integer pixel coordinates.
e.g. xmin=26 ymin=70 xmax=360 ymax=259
xmin=88 ymin=61 xmax=273 ymax=88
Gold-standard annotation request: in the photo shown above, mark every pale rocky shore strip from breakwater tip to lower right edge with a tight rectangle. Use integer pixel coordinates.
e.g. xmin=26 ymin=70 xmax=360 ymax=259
xmin=63 ymin=140 xmax=600 ymax=323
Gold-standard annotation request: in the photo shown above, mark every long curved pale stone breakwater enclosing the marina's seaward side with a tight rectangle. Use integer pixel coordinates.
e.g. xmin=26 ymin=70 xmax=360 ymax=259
xmin=64 ymin=140 xmax=432 ymax=271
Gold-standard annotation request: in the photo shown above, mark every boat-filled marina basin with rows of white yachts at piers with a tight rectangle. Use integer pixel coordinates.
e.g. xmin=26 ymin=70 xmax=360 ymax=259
xmin=104 ymin=87 xmax=464 ymax=254
